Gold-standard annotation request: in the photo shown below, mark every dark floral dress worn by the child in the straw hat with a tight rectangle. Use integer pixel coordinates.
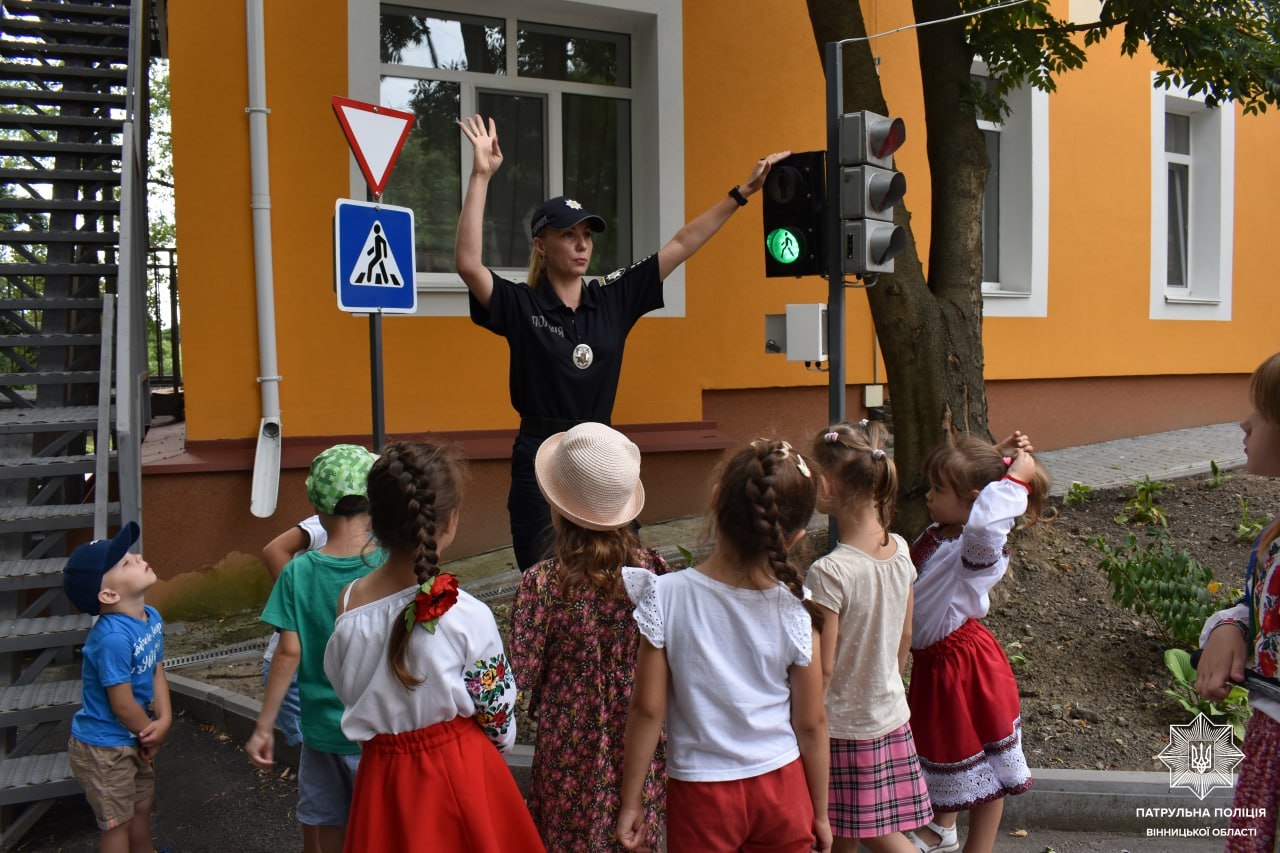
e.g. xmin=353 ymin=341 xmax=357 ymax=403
xmin=511 ymin=551 xmax=668 ymax=853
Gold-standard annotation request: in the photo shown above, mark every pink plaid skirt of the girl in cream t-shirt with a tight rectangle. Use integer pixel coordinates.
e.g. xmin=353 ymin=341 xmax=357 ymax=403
xmin=827 ymin=722 xmax=933 ymax=838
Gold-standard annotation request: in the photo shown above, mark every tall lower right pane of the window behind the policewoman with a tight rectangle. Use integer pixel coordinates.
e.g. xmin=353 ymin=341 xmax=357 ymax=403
xmin=563 ymin=95 xmax=632 ymax=275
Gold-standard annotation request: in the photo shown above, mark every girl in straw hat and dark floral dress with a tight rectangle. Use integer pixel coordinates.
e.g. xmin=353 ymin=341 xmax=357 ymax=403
xmin=511 ymin=423 xmax=667 ymax=852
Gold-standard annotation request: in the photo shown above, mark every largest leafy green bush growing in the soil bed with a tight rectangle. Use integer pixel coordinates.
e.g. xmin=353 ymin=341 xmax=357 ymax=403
xmin=1089 ymin=528 xmax=1226 ymax=648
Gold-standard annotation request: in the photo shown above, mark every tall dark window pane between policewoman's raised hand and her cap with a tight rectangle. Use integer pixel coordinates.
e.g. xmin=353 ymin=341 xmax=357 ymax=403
xmin=476 ymin=91 xmax=550 ymax=269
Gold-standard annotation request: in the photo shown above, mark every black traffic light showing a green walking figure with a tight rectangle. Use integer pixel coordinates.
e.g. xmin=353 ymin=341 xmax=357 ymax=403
xmin=762 ymin=151 xmax=827 ymax=278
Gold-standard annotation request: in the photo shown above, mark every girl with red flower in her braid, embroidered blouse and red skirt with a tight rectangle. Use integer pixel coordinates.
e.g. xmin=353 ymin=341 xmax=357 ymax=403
xmin=324 ymin=443 xmax=543 ymax=853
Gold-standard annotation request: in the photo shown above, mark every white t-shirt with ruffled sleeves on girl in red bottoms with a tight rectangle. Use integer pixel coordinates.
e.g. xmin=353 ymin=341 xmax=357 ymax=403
xmin=622 ymin=567 xmax=813 ymax=781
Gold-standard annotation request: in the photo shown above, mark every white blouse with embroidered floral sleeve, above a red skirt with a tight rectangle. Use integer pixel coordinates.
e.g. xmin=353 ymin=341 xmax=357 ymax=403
xmin=324 ymin=580 xmax=516 ymax=752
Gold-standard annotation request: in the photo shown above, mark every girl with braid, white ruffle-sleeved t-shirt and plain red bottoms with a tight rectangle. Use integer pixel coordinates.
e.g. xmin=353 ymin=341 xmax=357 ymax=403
xmin=618 ymin=439 xmax=831 ymax=853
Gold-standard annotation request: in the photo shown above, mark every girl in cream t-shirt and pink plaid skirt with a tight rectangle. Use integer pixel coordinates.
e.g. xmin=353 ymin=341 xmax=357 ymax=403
xmin=804 ymin=420 xmax=933 ymax=853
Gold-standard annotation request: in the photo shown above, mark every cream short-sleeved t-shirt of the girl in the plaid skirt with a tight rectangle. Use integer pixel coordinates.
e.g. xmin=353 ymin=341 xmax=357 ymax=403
xmin=804 ymin=534 xmax=915 ymax=740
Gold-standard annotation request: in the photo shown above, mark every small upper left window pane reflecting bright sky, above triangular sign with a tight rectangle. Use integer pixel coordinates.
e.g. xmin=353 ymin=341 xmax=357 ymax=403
xmin=379 ymin=6 xmax=507 ymax=74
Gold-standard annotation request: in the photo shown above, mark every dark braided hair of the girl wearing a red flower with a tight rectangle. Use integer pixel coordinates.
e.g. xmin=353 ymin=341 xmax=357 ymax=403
xmin=369 ymin=443 xmax=465 ymax=689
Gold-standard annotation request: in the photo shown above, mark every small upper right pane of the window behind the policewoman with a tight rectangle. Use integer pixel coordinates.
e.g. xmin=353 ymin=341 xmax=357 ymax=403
xmin=516 ymin=20 xmax=631 ymax=86
